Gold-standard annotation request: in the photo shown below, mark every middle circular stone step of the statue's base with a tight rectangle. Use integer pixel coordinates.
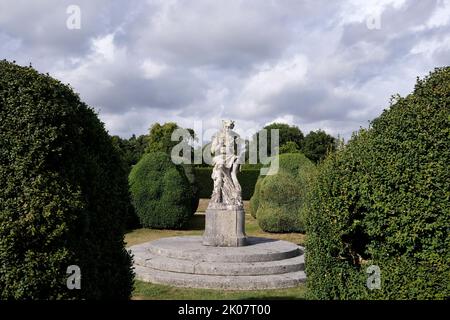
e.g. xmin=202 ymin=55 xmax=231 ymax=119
xmin=136 ymin=253 xmax=304 ymax=276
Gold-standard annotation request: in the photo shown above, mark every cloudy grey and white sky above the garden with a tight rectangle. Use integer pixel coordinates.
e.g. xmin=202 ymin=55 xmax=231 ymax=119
xmin=0 ymin=0 xmax=450 ymax=138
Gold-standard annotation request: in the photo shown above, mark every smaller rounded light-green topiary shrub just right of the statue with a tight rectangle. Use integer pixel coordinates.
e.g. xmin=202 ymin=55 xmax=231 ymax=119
xmin=253 ymin=153 xmax=315 ymax=232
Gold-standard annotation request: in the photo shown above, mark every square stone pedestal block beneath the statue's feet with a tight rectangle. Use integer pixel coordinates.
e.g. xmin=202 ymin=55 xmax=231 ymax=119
xmin=203 ymin=208 xmax=247 ymax=247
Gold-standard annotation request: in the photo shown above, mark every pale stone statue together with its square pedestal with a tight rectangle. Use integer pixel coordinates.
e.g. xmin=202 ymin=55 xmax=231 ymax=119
xmin=203 ymin=120 xmax=247 ymax=247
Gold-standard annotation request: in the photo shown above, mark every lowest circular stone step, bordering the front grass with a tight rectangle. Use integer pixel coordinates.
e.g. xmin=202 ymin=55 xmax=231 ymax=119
xmin=135 ymin=266 xmax=306 ymax=290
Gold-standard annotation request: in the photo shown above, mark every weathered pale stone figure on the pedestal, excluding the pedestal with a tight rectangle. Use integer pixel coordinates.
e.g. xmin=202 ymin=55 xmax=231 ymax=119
xmin=209 ymin=120 xmax=243 ymax=209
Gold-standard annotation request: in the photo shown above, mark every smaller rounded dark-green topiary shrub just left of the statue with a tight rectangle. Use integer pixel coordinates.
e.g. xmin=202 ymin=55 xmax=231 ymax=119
xmin=129 ymin=152 xmax=194 ymax=229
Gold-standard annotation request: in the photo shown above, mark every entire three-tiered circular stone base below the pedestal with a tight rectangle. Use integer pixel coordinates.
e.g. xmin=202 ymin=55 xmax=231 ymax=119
xmin=129 ymin=236 xmax=306 ymax=290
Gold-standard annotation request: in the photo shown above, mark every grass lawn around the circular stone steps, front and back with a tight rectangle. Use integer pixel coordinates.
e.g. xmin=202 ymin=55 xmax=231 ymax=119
xmin=125 ymin=199 xmax=306 ymax=300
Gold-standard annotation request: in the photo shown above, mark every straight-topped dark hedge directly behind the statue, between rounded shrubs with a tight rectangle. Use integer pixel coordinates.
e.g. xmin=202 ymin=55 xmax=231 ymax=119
xmin=194 ymin=167 xmax=259 ymax=200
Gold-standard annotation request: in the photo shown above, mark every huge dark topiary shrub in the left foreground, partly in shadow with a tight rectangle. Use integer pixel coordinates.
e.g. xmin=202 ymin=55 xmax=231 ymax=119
xmin=0 ymin=61 xmax=133 ymax=299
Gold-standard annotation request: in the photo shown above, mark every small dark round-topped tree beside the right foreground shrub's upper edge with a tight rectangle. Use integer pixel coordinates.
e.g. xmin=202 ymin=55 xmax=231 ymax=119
xmin=302 ymin=130 xmax=336 ymax=162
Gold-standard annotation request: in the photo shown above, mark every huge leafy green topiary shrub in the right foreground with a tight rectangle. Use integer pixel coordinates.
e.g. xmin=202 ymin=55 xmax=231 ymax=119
xmin=306 ymin=67 xmax=450 ymax=299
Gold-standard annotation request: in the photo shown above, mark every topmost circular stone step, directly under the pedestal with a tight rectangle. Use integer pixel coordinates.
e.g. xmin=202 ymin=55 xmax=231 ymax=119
xmin=130 ymin=236 xmax=303 ymax=263
